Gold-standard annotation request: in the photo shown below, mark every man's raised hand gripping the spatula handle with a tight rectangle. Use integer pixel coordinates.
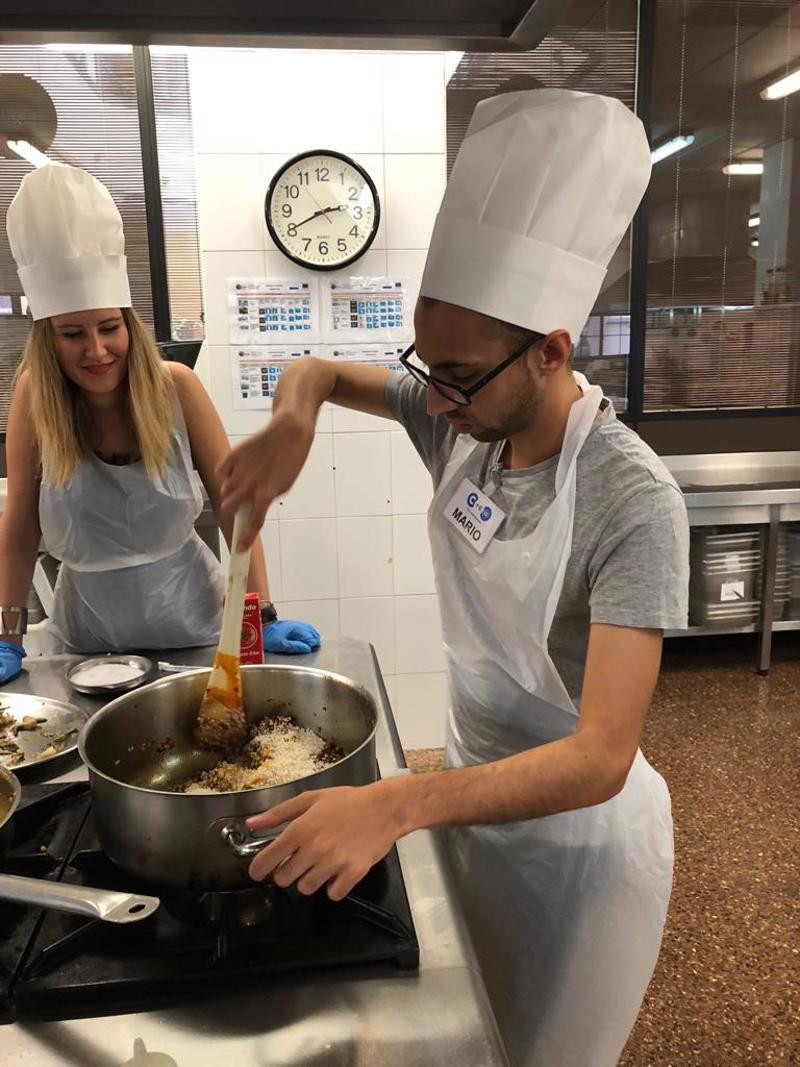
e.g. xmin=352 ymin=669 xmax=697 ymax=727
xmin=219 ymin=412 xmax=314 ymax=552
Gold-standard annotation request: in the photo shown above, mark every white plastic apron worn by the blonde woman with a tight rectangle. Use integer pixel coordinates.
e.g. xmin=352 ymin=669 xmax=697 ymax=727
xmin=39 ymin=397 xmax=225 ymax=652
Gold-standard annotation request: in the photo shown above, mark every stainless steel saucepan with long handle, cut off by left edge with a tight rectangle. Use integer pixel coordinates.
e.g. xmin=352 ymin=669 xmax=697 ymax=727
xmin=0 ymin=767 xmax=159 ymax=923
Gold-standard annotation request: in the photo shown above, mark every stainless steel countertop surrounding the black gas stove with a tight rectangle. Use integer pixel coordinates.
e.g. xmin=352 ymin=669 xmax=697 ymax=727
xmin=0 ymin=638 xmax=508 ymax=1067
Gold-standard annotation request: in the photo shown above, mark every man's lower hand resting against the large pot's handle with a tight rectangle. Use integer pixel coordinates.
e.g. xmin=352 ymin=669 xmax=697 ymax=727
xmin=247 ymin=779 xmax=406 ymax=901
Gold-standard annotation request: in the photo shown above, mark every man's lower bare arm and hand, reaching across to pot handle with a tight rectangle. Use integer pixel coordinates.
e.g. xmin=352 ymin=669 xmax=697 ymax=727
xmin=247 ymin=624 xmax=661 ymax=899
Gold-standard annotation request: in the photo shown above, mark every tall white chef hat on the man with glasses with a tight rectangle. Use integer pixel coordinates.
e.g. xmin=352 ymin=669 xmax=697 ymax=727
xmin=420 ymin=89 xmax=651 ymax=339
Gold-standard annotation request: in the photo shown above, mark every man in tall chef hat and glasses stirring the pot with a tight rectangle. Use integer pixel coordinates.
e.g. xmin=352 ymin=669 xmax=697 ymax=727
xmin=223 ymin=90 xmax=688 ymax=1067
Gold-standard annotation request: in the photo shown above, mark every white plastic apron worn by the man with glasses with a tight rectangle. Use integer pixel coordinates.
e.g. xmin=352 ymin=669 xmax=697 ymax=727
xmin=429 ymin=376 xmax=673 ymax=1067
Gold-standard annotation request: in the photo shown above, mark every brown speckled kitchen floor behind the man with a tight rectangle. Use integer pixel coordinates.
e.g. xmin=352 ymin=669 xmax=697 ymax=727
xmin=409 ymin=634 xmax=800 ymax=1067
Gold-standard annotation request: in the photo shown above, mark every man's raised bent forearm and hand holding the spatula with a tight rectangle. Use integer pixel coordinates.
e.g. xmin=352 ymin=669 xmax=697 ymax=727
xmin=219 ymin=357 xmax=394 ymax=548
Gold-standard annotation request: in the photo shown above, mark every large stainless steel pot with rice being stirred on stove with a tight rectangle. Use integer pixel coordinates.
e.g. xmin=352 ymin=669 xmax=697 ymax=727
xmin=78 ymin=665 xmax=378 ymax=891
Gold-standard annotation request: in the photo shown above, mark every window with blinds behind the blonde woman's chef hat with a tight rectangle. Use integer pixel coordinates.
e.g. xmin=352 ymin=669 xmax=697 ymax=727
xmin=0 ymin=45 xmax=203 ymax=432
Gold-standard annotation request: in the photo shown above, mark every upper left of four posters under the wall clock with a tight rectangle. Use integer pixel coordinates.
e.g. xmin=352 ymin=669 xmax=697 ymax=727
xmin=226 ymin=277 xmax=319 ymax=345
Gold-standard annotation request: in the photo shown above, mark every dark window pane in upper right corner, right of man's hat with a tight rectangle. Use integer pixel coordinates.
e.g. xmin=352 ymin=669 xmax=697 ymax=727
xmin=644 ymin=0 xmax=800 ymax=411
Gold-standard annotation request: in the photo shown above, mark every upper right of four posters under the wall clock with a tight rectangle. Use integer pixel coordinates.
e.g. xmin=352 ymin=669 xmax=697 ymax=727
xmin=320 ymin=276 xmax=414 ymax=344
